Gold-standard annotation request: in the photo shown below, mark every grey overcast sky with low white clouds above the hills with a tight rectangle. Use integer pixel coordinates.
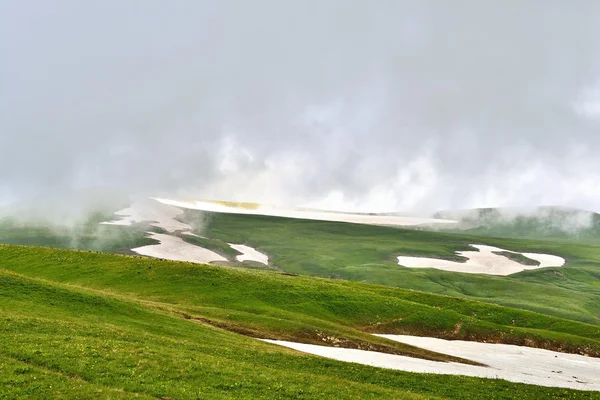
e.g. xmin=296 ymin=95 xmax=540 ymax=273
xmin=0 ymin=0 xmax=600 ymax=216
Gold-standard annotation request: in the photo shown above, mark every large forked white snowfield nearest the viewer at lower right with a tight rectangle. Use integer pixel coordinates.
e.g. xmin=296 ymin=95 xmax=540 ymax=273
xmin=262 ymin=335 xmax=600 ymax=391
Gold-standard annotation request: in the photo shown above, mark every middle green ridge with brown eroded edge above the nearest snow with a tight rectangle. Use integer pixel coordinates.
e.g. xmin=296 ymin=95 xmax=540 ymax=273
xmin=0 ymin=246 xmax=600 ymax=358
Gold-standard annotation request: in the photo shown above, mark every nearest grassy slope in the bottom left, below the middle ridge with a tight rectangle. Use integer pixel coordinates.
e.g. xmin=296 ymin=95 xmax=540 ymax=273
xmin=0 ymin=268 xmax=419 ymax=399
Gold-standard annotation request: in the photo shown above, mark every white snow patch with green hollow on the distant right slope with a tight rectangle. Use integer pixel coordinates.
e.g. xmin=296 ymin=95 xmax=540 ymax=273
xmin=398 ymin=244 xmax=565 ymax=275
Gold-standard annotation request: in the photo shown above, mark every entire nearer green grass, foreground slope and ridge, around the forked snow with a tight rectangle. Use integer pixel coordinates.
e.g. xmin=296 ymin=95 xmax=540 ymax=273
xmin=0 ymin=246 xmax=600 ymax=399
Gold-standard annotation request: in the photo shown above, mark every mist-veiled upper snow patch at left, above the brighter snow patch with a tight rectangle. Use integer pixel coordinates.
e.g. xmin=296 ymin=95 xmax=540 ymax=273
xmin=101 ymin=200 xmax=192 ymax=232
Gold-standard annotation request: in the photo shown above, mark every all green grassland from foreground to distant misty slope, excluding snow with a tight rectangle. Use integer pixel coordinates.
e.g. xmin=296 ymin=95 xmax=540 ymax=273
xmin=0 ymin=210 xmax=600 ymax=399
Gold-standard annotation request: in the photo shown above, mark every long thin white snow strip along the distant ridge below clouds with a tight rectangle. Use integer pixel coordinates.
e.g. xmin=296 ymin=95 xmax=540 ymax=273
xmin=154 ymin=198 xmax=457 ymax=226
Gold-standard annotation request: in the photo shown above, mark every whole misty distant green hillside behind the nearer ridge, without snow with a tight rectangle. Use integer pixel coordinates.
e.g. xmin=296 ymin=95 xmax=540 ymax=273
xmin=0 ymin=202 xmax=600 ymax=324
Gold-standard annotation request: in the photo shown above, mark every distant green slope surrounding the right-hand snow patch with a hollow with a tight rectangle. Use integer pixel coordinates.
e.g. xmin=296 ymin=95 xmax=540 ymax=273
xmin=183 ymin=211 xmax=600 ymax=324
